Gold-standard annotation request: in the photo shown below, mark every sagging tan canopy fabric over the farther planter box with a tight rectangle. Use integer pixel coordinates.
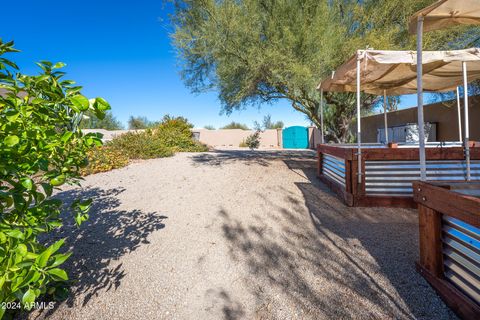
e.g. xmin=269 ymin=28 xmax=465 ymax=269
xmin=317 ymin=48 xmax=480 ymax=95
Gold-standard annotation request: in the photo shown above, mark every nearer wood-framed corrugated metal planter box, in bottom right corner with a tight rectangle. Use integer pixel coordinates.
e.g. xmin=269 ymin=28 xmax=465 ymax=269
xmin=413 ymin=182 xmax=480 ymax=319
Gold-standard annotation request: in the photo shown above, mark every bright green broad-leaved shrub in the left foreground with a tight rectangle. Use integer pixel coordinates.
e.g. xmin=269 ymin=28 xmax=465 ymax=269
xmin=0 ymin=40 xmax=110 ymax=318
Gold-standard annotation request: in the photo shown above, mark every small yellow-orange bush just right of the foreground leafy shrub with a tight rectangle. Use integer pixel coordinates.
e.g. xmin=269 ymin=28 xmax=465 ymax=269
xmin=80 ymin=146 xmax=128 ymax=176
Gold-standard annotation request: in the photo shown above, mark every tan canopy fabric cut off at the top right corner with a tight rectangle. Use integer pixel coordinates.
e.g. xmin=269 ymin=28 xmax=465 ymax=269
xmin=408 ymin=0 xmax=480 ymax=34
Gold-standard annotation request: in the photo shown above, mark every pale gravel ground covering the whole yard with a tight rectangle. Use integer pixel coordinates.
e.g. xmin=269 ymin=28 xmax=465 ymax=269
xmin=30 ymin=151 xmax=455 ymax=320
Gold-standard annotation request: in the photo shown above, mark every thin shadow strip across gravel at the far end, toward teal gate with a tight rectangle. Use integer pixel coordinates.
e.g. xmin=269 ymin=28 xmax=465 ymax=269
xmin=192 ymin=150 xmax=315 ymax=166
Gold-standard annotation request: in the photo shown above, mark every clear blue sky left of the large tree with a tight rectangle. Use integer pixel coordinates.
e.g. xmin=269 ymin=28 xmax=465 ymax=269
xmin=0 ymin=0 xmax=424 ymax=128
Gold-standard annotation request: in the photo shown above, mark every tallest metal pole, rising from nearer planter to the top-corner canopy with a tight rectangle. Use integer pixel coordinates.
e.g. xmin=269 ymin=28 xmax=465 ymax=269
xmin=417 ymin=16 xmax=427 ymax=181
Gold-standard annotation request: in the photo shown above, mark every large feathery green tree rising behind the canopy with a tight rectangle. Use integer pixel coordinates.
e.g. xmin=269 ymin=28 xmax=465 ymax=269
xmin=173 ymin=0 xmax=474 ymax=141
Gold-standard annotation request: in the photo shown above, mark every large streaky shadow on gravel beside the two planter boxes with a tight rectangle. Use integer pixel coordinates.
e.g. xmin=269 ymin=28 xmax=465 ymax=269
xmin=219 ymin=159 xmax=455 ymax=319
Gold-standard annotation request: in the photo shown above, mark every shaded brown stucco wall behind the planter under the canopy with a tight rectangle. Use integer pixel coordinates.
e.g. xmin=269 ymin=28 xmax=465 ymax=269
xmin=362 ymin=96 xmax=480 ymax=143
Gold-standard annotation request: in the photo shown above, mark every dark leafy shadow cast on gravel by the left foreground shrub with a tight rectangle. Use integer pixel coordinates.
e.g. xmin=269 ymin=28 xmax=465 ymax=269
xmin=37 ymin=188 xmax=167 ymax=317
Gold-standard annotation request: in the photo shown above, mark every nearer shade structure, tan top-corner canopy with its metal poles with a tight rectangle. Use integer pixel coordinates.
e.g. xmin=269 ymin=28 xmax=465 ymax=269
xmin=409 ymin=0 xmax=480 ymax=181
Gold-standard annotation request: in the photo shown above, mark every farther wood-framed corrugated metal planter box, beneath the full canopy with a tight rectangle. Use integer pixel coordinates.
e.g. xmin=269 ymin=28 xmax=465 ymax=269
xmin=317 ymin=144 xmax=480 ymax=208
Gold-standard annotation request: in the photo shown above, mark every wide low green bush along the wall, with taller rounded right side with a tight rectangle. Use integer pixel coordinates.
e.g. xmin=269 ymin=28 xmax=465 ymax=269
xmin=107 ymin=115 xmax=208 ymax=159
